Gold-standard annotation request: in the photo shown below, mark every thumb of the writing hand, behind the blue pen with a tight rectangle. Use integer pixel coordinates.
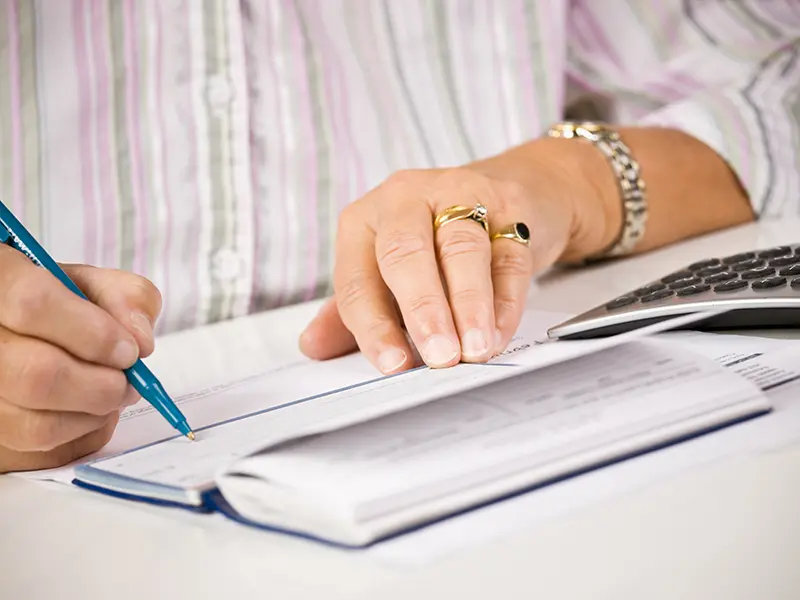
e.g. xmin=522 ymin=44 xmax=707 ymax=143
xmin=61 ymin=265 xmax=161 ymax=357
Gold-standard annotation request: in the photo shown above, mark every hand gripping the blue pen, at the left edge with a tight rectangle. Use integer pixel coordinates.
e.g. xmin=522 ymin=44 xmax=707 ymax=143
xmin=0 ymin=245 xmax=161 ymax=473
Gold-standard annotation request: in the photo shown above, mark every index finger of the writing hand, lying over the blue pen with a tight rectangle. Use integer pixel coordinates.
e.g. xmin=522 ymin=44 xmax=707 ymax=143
xmin=0 ymin=245 xmax=139 ymax=369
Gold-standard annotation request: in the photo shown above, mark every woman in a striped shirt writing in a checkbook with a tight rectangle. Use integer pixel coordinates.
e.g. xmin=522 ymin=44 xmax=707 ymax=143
xmin=0 ymin=0 xmax=800 ymax=471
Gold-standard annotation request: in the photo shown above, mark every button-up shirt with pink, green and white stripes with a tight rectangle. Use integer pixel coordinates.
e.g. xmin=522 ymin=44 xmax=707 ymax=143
xmin=0 ymin=0 xmax=800 ymax=333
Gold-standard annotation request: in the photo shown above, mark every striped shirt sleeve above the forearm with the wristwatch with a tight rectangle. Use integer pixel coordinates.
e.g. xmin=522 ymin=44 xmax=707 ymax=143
xmin=564 ymin=0 xmax=800 ymax=218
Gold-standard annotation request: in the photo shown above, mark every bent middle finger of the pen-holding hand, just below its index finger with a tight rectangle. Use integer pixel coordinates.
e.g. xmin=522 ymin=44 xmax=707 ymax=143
xmin=0 ymin=327 xmax=129 ymax=416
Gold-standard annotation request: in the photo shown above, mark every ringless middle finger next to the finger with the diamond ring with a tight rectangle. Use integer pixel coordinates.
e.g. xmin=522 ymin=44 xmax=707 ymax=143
xmin=372 ymin=182 xmax=461 ymax=367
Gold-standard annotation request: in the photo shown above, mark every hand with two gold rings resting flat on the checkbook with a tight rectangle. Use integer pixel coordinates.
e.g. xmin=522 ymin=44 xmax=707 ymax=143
xmin=301 ymin=139 xmax=613 ymax=374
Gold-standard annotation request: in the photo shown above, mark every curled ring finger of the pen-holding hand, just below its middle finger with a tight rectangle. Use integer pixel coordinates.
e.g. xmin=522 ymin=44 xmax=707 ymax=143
xmin=0 ymin=400 xmax=113 ymax=452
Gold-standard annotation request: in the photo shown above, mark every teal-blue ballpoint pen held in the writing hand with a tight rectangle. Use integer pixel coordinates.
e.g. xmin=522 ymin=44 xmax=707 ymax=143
xmin=0 ymin=202 xmax=194 ymax=440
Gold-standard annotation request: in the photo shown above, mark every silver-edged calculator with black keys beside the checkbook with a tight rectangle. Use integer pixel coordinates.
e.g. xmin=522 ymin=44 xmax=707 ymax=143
xmin=548 ymin=243 xmax=800 ymax=339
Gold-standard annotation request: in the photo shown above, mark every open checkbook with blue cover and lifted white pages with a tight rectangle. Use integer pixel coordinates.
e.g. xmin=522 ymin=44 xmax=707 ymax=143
xmin=74 ymin=339 xmax=771 ymax=548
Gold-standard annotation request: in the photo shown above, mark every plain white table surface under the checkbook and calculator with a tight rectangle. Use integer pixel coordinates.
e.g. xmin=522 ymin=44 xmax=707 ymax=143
xmin=0 ymin=221 xmax=800 ymax=600
